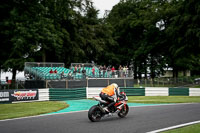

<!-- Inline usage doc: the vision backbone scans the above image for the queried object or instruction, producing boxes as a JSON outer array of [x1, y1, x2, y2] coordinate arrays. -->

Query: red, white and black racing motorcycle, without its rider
[[88, 92, 129, 122]]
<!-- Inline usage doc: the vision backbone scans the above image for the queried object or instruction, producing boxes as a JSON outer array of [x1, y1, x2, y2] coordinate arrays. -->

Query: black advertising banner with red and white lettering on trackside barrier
[[0, 89, 38, 103]]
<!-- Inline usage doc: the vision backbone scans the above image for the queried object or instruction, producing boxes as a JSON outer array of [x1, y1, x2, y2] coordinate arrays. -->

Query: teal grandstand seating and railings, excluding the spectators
[[24, 62, 121, 80]]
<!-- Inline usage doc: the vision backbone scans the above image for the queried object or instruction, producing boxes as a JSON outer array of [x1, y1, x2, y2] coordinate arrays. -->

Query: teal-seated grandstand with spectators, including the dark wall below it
[[24, 62, 133, 88]]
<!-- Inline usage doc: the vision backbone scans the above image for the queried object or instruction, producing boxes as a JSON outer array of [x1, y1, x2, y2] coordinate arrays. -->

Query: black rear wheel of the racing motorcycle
[[88, 105, 102, 122]]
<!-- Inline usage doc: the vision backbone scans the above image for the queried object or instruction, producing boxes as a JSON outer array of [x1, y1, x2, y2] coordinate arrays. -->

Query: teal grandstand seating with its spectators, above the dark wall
[[24, 62, 133, 80]]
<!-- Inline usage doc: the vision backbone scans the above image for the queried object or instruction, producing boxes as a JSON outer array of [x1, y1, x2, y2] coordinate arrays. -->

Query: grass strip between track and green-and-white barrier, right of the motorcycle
[[128, 96, 200, 103]]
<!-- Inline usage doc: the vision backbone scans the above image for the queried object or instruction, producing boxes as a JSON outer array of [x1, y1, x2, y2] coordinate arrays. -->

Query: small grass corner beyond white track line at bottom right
[[162, 124, 200, 133]]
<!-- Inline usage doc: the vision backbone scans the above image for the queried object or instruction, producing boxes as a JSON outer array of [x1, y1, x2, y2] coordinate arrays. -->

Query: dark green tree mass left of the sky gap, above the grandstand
[[0, 0, 114, 79]]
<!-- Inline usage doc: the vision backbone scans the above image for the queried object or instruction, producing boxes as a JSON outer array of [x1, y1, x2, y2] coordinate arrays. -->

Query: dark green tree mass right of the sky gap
[[107, 0, 200, 78]]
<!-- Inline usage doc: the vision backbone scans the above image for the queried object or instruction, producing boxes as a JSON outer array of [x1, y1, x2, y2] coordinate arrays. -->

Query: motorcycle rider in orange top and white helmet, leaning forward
[[99, 83, 120, 113]]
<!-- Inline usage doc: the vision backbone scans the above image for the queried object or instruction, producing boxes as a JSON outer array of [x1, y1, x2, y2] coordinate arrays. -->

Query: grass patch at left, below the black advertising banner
[[0, 101, 69, 120]]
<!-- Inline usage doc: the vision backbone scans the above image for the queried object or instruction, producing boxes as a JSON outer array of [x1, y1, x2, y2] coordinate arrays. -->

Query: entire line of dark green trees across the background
[[0, 0, 200, 79]]
